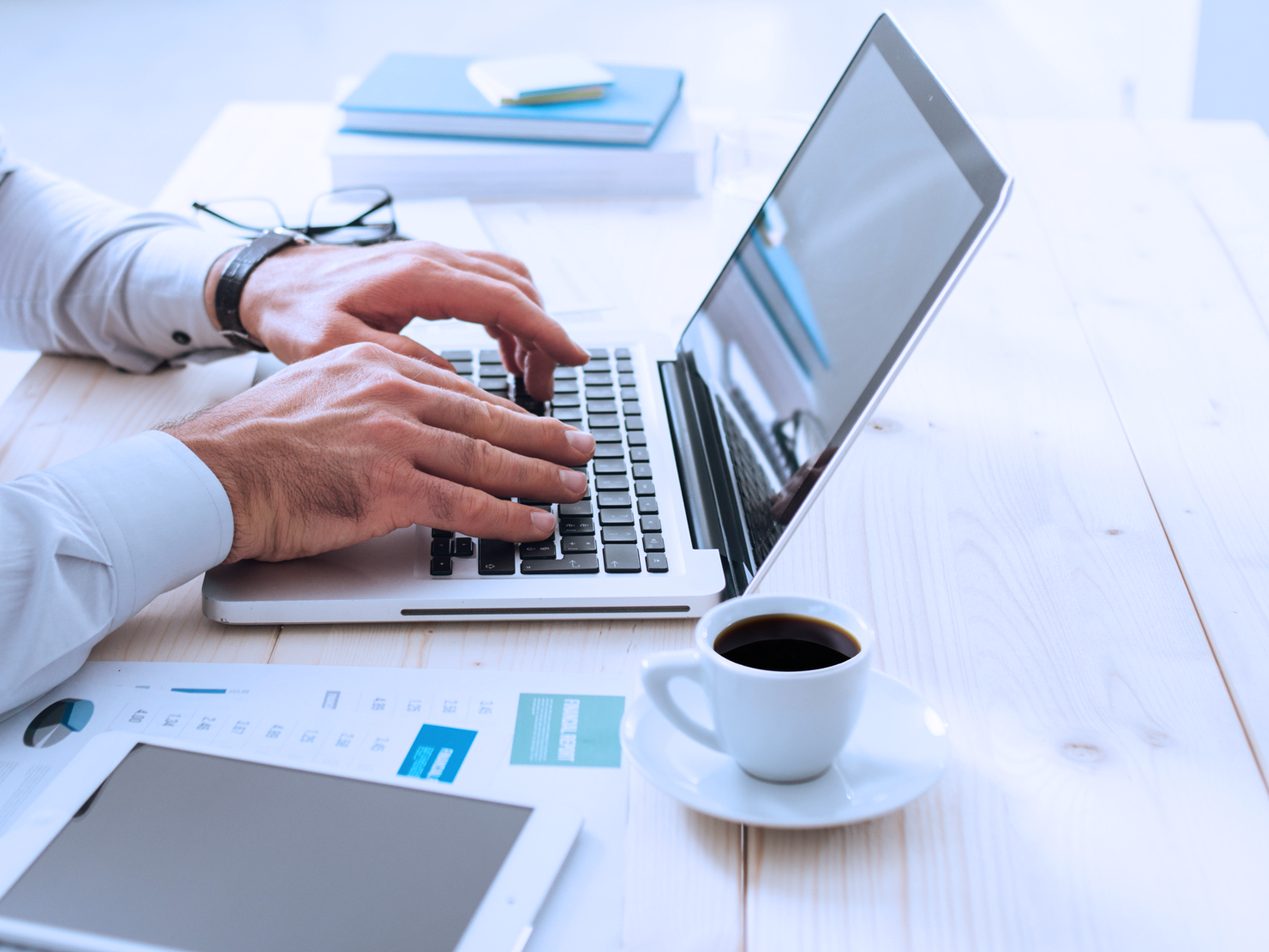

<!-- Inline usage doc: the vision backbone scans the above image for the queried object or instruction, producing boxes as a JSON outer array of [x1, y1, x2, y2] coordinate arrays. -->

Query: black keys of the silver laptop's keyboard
[[430, 348, 670, 578]]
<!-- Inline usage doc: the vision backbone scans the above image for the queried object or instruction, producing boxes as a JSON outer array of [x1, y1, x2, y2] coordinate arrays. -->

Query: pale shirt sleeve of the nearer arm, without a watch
[[0, 432, 233, 716]]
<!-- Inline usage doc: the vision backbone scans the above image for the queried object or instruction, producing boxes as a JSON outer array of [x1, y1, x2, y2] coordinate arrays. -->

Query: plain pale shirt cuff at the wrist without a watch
[[47, 431, 233, 630]]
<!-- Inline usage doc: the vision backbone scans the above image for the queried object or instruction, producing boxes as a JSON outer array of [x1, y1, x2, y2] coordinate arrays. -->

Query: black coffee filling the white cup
[[714, 614, 862, 671]]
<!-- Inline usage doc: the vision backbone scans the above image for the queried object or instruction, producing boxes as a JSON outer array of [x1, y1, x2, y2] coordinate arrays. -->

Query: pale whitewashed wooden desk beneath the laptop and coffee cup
[[0, 104, 1269, 949]]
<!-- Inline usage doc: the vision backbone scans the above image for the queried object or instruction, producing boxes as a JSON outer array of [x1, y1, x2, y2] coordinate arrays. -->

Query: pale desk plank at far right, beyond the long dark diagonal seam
[[1015, 123, 1269, 770]]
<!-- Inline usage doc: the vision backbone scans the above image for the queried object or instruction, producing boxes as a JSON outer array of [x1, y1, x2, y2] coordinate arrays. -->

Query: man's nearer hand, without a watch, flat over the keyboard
[[166, 344, 595, 562]]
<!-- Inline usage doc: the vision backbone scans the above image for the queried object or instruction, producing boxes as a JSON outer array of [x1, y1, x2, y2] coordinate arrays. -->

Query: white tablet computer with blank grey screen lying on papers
[[0, 734, 581, 952]]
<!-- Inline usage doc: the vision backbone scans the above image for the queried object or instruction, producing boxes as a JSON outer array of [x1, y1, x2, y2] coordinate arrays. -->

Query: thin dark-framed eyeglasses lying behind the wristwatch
[[193, 187, 401, 245]]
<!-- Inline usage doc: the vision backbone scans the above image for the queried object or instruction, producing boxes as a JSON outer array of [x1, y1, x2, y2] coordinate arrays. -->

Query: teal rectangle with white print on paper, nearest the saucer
[[511, 694, 626, 767]]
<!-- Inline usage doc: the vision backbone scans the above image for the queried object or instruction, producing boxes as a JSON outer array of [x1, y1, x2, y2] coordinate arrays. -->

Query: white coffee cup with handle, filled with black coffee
[[642, 595, 874, 783]]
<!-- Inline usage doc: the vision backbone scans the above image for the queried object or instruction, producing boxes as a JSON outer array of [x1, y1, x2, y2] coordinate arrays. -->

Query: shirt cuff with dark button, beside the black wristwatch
[[127, 225, 242, 360]]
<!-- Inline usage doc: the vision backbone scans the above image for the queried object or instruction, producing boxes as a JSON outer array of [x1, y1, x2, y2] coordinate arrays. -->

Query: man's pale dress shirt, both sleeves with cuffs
[[0, 135, 233, 716]]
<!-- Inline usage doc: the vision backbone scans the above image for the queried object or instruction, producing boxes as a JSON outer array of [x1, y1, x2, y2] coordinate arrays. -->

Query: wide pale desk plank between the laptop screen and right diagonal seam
[[746, 123, 1269, 949]]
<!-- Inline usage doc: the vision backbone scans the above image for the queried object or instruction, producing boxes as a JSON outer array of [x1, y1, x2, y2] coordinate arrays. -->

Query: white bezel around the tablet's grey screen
[[0, 731, 581, 952]]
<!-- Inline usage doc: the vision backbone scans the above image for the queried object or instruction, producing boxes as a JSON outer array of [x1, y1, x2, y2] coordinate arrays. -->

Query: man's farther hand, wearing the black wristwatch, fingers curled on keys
[[208, 241, 586, 400]]
